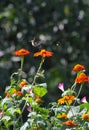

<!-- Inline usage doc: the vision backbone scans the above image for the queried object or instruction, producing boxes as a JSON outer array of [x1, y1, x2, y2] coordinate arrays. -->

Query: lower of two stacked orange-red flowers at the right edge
[[75, 72, 89, 83]]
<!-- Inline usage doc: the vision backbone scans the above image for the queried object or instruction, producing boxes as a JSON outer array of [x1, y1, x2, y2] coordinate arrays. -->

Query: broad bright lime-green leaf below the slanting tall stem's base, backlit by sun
[[33, 86, 47, 97]]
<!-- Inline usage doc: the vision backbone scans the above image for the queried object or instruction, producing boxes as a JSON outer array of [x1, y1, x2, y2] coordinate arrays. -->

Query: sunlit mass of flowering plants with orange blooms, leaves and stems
[[0, 49, 89, 130]]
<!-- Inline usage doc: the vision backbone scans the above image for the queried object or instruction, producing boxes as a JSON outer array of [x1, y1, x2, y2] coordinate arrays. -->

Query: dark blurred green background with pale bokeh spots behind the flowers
[[0, 0, 89, 101]]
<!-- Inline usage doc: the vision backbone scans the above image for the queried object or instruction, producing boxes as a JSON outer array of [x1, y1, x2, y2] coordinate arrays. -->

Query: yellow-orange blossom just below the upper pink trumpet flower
[[58, 95, 75, 104]]
